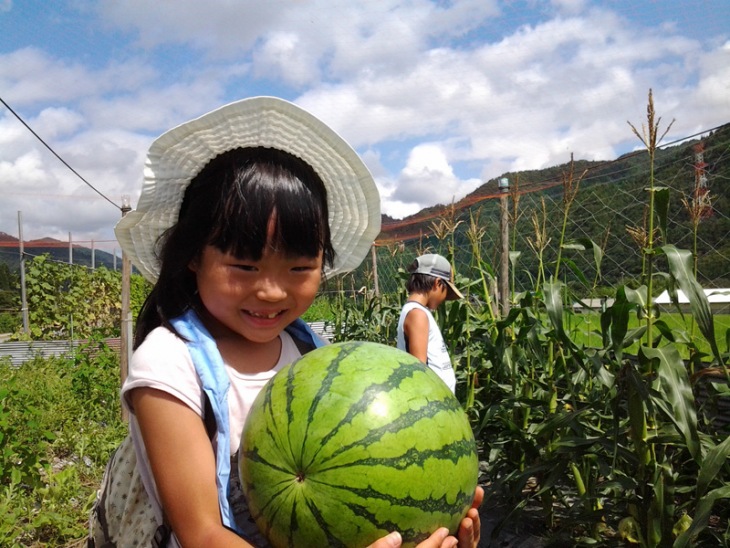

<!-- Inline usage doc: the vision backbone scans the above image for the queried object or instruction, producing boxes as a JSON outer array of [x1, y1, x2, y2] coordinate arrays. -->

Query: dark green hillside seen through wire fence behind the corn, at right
[[339, 126, 730, 297]]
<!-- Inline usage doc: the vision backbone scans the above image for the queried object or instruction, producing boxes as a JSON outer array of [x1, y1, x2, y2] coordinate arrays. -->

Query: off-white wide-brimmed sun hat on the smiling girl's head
[[114, 97, 380, 282]]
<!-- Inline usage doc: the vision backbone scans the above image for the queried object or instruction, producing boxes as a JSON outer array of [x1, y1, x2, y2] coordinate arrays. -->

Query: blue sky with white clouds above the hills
[[0, 0, 730, 251]]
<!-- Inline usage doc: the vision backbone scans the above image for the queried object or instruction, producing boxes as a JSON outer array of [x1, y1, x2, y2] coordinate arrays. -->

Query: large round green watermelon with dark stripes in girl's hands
[[239, 342, 478, 548]]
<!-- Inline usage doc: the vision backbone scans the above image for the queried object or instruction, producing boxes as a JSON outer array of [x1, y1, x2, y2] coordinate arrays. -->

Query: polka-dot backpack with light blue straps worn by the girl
[[87, 310, 325, 548]]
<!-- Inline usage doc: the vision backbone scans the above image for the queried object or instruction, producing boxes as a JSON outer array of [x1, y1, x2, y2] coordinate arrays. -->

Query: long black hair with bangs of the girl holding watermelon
[[134, 147, 335, 348]]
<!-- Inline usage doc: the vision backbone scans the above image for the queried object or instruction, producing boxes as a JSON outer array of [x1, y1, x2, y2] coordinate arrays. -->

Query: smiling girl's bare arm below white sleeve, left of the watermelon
[[129, 388, 250, 547]]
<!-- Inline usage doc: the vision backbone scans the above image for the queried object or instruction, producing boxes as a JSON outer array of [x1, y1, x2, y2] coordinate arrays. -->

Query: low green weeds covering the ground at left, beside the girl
[[0, 341, 126, 546]]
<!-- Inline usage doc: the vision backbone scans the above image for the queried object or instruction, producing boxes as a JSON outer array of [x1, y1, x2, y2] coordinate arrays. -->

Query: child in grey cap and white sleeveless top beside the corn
[[397, 254, 464, 392]]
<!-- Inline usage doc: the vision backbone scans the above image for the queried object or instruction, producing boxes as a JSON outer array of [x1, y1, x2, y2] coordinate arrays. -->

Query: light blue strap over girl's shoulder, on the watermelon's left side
[[170, 310, 236, 529]]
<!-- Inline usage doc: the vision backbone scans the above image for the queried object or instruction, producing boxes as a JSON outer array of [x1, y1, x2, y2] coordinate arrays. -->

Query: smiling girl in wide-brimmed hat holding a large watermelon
[[116, 97, 482, 548]]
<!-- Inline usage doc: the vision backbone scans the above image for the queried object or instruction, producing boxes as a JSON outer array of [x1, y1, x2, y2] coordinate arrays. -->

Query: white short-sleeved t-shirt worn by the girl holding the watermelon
[[122, 327, 301, 547]]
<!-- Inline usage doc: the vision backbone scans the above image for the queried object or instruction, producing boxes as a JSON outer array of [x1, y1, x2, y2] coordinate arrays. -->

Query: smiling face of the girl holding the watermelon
[[190, 246, 322, 343]]
